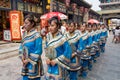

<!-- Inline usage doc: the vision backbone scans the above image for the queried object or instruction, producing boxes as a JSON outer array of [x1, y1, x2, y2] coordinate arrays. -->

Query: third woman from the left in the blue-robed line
[[65, 22, 81, 80]]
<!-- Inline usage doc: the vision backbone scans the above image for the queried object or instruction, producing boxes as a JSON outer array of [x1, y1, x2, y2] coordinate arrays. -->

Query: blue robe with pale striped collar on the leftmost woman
[[19, 29, 43, 79]]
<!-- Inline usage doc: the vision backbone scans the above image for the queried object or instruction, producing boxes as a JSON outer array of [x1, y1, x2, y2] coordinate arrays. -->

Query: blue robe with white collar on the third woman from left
[[65, 32, 81, 80]]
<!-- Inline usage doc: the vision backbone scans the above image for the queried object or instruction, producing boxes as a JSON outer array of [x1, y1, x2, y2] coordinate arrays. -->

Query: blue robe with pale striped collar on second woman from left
[[46, 33, 72, 80]]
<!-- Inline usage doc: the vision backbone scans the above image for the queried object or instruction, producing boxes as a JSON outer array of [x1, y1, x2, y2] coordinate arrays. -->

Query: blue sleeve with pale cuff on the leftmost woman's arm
[[30, 33, 42, 61]]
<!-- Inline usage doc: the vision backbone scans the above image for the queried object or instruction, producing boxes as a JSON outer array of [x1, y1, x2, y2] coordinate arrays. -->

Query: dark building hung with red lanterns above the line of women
[[46, 0, 91, 23]]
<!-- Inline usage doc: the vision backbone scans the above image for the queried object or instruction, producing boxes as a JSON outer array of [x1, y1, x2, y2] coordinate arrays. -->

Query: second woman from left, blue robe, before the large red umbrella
[[45, 17, 72, 80]]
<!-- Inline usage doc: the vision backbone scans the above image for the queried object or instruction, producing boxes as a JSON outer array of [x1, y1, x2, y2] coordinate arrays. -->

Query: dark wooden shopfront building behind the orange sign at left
[[0, 0, 45, 40]]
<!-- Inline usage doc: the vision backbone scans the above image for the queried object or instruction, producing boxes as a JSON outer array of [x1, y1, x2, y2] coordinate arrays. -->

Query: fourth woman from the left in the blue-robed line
[[79, 24, 90, 77]]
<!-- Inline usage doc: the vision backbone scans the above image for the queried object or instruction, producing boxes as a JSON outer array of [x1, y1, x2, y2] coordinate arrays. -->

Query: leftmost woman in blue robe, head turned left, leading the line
[[19, 14, 43, 80]]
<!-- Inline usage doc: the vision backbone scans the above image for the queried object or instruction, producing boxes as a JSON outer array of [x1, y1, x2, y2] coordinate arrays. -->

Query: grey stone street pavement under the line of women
[[0, 35, 120, 80]]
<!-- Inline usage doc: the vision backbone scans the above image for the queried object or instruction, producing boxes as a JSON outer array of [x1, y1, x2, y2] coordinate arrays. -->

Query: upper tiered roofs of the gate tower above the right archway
[[99, 0, 120, 25]]
